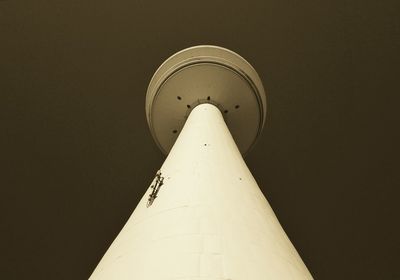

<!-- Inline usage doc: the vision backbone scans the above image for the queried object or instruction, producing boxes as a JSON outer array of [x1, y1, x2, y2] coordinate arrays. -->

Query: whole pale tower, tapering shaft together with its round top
[[90, 46, 312, 280]]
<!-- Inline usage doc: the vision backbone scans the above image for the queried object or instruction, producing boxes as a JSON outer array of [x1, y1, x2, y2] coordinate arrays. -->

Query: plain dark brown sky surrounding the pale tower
[[0, 0, 400, 279]]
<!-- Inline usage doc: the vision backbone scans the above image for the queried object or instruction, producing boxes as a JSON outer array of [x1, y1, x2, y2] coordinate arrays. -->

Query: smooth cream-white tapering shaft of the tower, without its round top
[[90, 104, 312, 280]]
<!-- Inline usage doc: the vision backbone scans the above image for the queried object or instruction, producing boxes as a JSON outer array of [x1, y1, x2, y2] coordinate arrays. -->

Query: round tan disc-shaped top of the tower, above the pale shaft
[[146, 45, 267, 154]]
